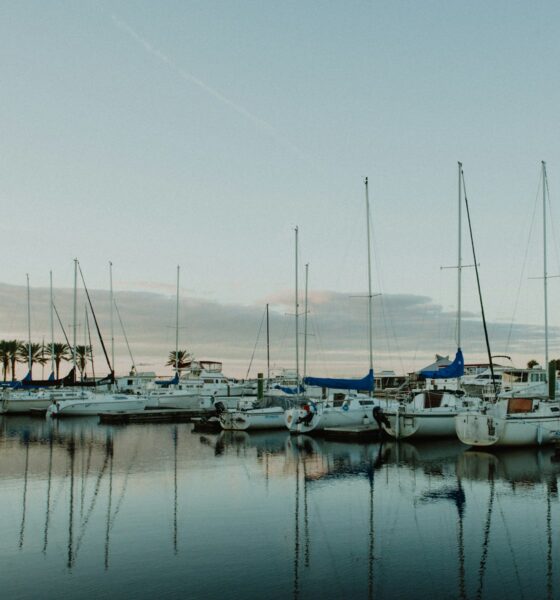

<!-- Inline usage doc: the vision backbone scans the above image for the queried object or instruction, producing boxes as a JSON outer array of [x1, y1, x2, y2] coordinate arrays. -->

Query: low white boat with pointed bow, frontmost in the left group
[[47, 391, 146, 417]]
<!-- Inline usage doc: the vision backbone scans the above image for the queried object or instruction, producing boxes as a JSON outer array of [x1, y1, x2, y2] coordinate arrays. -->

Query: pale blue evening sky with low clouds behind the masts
[[0, 0, 560, 375]]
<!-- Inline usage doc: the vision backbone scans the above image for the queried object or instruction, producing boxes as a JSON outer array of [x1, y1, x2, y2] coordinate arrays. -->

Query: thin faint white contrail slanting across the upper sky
[[111, 14, 306, 159]]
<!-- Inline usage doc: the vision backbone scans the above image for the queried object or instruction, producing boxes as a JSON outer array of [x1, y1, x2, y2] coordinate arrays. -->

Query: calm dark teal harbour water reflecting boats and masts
[[0, 417, 560, 600]]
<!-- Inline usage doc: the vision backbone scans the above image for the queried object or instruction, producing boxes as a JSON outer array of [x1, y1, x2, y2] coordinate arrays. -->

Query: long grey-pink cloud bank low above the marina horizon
[[0, 284, 560, 376]]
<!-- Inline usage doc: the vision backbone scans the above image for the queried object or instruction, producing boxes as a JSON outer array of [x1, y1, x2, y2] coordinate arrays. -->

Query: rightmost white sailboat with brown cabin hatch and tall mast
[[455, 161, 560, 446]]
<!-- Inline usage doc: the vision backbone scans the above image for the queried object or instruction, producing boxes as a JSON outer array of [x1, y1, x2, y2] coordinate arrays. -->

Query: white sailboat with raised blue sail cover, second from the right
[[381, 163, 481, 439]]
